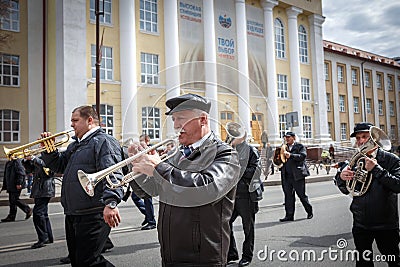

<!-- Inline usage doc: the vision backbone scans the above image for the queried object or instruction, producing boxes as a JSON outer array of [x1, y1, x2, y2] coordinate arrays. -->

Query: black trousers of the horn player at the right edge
[[352, 227, 400, 267]]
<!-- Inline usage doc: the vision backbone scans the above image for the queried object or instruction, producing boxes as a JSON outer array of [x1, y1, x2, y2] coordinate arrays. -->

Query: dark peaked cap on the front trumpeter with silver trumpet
[[165, 94, 211, 115]]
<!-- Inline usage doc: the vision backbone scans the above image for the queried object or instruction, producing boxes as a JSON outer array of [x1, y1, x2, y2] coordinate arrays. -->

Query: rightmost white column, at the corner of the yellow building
[[308, 14, 330, 143]]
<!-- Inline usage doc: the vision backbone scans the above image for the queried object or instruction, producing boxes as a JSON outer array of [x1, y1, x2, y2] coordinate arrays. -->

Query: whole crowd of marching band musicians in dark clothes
[[1, 94, 400, 266]]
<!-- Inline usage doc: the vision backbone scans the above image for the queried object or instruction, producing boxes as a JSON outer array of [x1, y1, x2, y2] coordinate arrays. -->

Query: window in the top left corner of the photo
[[0, 0, 20, 32]]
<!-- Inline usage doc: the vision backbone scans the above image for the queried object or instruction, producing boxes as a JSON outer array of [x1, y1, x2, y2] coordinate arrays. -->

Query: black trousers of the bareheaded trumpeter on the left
[[65, 212, 114, 267]]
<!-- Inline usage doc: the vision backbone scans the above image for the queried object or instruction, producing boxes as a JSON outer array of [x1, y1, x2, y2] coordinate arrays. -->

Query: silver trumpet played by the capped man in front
[[78, 138, 179, 197]]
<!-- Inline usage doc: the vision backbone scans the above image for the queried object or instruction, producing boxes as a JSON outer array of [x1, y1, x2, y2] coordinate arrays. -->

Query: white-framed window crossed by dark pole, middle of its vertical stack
[[91, 45, 113, 81]]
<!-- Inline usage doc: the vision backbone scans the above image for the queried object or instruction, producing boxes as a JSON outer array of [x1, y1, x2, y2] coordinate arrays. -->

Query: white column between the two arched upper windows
[[286, 7, 303, 140]]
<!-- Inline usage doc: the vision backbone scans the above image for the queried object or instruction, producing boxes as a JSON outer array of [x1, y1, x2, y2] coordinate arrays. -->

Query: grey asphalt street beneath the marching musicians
[[0, 181, 386, 267]]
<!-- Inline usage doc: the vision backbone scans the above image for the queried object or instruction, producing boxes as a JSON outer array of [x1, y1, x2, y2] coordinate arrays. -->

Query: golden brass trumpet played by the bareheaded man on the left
[[4, 130, 74, 160]]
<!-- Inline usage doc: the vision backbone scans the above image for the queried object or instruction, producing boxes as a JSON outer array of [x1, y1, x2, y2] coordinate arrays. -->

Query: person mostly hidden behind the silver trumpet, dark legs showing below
[[131, 134, 157, 230]]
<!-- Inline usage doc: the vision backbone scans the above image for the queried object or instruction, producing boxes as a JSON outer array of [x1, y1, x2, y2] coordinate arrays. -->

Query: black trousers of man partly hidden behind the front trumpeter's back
[[228, 198, 258, 261]]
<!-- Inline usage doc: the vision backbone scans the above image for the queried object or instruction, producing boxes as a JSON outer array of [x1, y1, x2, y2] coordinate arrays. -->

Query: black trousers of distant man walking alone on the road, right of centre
[[282, 175, 312, 217]]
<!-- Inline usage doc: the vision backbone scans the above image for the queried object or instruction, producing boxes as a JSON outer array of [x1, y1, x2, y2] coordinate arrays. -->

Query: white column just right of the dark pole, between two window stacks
[[119, 1, 140, 142]]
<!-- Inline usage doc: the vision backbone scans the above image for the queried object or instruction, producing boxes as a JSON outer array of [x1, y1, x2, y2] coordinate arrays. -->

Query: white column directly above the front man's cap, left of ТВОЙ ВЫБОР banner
[[203, 0, 221, 137]]
